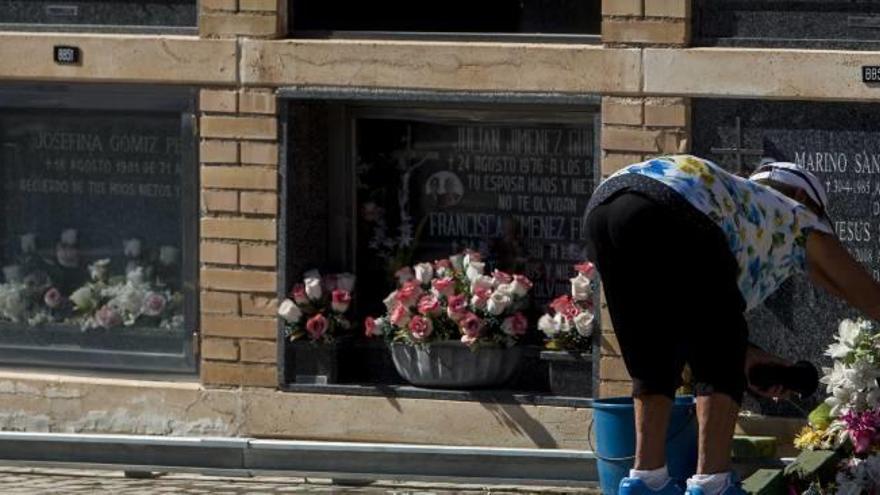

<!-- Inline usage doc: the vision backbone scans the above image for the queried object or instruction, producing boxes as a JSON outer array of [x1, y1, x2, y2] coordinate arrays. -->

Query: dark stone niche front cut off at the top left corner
[[0, 0, 198, 33]]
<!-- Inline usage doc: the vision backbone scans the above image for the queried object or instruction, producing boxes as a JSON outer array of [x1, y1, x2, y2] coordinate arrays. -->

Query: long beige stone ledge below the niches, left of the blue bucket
[[0, 372, 592, 450]]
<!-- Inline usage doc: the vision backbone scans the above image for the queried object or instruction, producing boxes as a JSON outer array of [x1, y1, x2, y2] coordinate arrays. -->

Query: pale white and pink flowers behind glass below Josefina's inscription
[[0, 229, 184, 331]]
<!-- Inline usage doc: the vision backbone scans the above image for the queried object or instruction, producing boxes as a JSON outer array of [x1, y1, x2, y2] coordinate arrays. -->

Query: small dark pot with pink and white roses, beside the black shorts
[[538, 262, 596, 397]]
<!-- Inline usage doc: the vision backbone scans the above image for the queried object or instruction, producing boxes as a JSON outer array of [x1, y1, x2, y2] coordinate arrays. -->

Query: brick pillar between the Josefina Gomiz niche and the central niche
[[199, 90, 278, 387]]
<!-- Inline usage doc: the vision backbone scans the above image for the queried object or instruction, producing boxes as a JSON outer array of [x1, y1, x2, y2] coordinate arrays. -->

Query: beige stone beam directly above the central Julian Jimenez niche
[[241, 40, 641, 94]]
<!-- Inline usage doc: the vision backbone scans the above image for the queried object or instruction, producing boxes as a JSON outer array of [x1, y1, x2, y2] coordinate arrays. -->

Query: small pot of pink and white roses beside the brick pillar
[[278, 270, 355, 384]]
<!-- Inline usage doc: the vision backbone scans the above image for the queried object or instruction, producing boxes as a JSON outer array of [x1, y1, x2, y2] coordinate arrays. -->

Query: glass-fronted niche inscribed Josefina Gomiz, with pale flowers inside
[[0, 87, 197, 372]]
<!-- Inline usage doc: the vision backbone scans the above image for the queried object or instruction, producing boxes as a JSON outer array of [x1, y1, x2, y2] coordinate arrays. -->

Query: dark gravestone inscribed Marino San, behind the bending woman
[[693, 99, 880, 415]]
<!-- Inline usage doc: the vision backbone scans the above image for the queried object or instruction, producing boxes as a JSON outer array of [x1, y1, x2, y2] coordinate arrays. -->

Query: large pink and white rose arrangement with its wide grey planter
[[365, 251, 532, 387]]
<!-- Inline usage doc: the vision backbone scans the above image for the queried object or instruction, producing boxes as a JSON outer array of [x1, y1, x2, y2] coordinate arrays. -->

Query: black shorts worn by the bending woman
[[586, 190, 748, 403]]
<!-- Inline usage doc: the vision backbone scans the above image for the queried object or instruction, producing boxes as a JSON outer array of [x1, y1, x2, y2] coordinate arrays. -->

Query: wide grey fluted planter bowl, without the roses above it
[[391, 341, 522, 389]]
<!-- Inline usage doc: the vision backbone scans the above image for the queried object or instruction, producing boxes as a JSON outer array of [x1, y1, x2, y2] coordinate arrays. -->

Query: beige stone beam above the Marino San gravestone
[[644, 48, 880, 100]]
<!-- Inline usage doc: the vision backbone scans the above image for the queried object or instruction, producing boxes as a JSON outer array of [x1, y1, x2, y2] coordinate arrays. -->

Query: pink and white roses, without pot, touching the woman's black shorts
[[538, 262, 596, 351]]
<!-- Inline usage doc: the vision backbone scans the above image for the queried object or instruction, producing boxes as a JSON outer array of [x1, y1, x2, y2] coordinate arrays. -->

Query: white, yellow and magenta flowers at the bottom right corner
[[791, 319, 880, 494]]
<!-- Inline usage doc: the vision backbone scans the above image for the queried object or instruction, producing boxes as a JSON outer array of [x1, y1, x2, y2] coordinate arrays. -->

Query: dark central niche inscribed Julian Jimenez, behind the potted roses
[[280, 90, 598, 393]]
